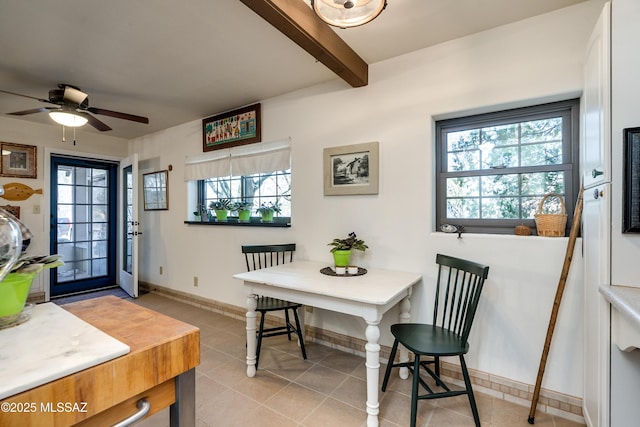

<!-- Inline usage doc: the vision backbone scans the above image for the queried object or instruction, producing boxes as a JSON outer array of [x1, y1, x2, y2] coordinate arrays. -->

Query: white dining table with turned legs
[[233, 261, 422, 427]]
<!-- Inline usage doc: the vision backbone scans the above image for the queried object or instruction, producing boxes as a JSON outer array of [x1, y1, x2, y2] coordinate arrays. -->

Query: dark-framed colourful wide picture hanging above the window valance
[[202, 104, 261, 151]]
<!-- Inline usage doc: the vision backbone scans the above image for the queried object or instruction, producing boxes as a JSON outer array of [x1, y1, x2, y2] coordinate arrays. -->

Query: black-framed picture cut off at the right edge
[[622, 127, 640, 233]]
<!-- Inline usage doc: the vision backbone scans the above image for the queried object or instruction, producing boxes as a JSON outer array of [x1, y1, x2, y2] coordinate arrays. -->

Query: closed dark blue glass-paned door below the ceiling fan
[[50, 156, 118, 296]]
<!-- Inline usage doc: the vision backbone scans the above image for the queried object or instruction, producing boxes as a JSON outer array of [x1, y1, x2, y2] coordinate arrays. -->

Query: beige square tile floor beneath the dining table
[[126, 293, 580, 427]]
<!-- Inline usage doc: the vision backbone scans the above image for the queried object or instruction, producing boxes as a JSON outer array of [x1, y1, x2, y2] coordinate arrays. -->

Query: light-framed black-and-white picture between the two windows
[[324, 142, 378, 196]]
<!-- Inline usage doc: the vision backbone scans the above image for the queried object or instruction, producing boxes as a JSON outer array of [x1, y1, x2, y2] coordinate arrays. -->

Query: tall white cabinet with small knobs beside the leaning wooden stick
[[581, 3, 612, 427]]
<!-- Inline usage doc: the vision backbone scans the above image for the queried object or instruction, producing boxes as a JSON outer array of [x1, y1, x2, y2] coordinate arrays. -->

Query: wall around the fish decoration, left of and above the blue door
[[0, 116, 128, 298]]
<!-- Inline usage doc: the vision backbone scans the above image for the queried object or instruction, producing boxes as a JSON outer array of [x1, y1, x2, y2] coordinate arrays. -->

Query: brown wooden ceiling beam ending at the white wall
[[240, 0, 369, 87]]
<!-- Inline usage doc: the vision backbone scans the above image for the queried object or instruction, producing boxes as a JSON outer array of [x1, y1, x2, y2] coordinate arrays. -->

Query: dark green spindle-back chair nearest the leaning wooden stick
[[382, 254, 489, 427]]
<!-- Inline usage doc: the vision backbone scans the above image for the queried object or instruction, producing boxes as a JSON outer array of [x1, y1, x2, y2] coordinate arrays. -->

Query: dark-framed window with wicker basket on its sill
[[436, 99, 579, 234]]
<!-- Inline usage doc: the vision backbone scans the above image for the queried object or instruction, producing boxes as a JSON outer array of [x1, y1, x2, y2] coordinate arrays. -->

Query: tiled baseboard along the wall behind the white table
[[138, 282, 584, 423]]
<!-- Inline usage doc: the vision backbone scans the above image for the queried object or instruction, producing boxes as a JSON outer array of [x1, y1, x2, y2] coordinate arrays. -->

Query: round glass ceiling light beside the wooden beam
[[311, 0, 387, 28]]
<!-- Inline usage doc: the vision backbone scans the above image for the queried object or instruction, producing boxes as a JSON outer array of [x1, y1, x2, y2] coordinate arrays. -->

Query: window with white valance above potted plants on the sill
[[198, 169, 291, 221]]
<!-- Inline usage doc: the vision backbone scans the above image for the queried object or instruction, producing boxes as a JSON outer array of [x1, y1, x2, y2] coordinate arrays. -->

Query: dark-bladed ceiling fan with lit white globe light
[[0, 83, 149, 132]]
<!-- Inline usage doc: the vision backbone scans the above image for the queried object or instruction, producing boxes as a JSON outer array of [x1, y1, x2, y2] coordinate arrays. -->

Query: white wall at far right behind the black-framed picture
[[611, 0, 640, 427]]
